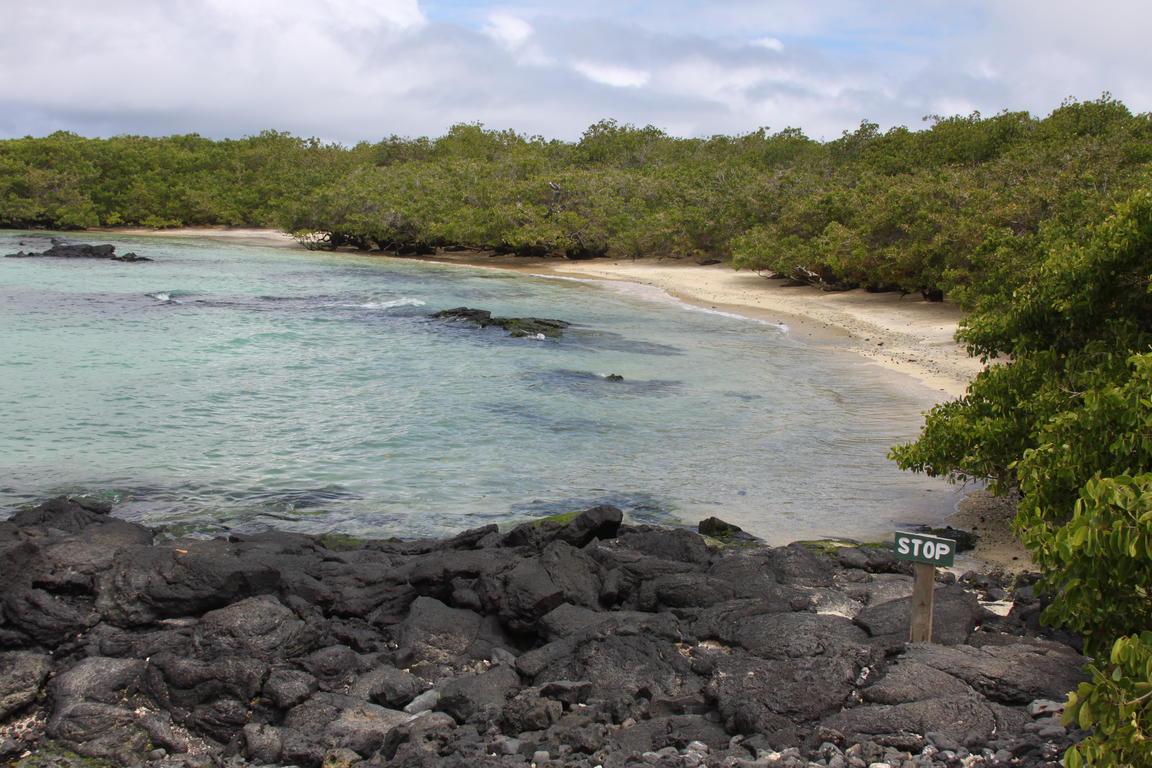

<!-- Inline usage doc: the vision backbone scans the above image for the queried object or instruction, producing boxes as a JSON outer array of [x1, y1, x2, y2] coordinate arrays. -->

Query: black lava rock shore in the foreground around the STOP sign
[[0, 497, 1084, 768]]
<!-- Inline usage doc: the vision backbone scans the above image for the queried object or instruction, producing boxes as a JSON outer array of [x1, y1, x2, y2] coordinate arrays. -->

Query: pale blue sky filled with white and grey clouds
[[0, 0, 1152, 145]]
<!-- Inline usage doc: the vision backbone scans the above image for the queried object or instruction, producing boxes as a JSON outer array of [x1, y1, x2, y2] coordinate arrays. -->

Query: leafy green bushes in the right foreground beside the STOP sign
[[893, 191, 1152, 766]]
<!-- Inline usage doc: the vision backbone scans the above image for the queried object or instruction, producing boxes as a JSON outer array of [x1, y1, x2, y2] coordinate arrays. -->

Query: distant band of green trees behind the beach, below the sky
[[0, 94, 1152, 305]]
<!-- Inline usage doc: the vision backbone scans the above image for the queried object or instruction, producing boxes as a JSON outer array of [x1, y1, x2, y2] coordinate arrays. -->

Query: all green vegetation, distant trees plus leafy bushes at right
[[0, 94, 1152, 768]]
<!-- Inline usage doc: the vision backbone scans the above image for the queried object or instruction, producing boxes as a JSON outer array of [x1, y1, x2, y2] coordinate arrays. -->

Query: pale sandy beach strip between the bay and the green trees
[[88, 227, 1031, 573]]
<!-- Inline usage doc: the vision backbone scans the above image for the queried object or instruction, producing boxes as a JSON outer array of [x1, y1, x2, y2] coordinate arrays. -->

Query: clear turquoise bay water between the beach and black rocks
[[0, 233, 956, 542]]
